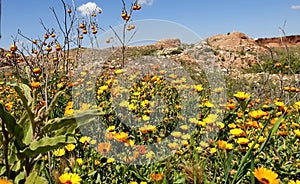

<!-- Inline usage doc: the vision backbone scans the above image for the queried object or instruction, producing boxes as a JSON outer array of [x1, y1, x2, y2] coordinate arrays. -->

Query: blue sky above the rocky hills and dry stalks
[[0, 0, 300, 49]]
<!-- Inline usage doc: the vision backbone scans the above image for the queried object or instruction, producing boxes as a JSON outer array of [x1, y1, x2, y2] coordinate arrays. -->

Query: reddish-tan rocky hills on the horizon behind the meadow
[[0, 32, 300, 70]]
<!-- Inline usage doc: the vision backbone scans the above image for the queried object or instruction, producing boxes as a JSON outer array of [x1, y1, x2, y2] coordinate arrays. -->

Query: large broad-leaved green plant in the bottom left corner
[[0, 84, 99, 183]]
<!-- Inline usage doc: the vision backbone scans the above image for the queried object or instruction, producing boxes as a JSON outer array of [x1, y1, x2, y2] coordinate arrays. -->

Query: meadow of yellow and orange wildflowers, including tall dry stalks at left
[[0, 0, 300, 184]]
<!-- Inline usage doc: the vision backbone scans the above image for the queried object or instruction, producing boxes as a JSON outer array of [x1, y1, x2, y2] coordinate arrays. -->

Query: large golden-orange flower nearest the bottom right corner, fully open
[[253, 167, 280, 184]]
